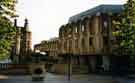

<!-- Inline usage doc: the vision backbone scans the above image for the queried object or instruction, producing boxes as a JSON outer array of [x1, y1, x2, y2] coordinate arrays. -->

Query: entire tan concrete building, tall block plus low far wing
[[35, 5, 127, 72]]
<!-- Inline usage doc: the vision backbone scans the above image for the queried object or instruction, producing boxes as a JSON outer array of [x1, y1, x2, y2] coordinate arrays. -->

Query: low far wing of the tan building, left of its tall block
[[34, 38, 58, 57]]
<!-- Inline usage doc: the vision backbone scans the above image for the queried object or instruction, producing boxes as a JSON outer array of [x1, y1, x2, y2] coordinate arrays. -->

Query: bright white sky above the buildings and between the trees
[[16, 0, 127, 45]]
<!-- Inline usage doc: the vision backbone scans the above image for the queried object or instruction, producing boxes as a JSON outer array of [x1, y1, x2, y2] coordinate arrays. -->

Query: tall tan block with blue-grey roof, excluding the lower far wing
[[58, 5, 123, 72]]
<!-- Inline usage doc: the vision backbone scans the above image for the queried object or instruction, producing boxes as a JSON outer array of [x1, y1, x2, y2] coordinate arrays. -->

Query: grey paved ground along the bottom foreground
[[0, 73, 135, 83]]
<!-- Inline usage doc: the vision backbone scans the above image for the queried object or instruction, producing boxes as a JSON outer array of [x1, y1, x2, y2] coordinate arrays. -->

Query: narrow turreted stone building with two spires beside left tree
[[12, 19, 32, 63]]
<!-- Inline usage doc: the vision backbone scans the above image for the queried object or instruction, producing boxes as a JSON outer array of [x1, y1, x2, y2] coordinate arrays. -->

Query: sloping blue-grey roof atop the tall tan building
[[69, 5, 124, 23]]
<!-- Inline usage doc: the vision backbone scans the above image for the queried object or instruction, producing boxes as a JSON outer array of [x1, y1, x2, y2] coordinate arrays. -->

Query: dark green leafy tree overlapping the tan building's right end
[[113, 0, 135, 55]]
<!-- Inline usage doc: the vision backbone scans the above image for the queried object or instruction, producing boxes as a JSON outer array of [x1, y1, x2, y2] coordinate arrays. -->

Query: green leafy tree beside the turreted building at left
[[0, 0, 17, 60]]
